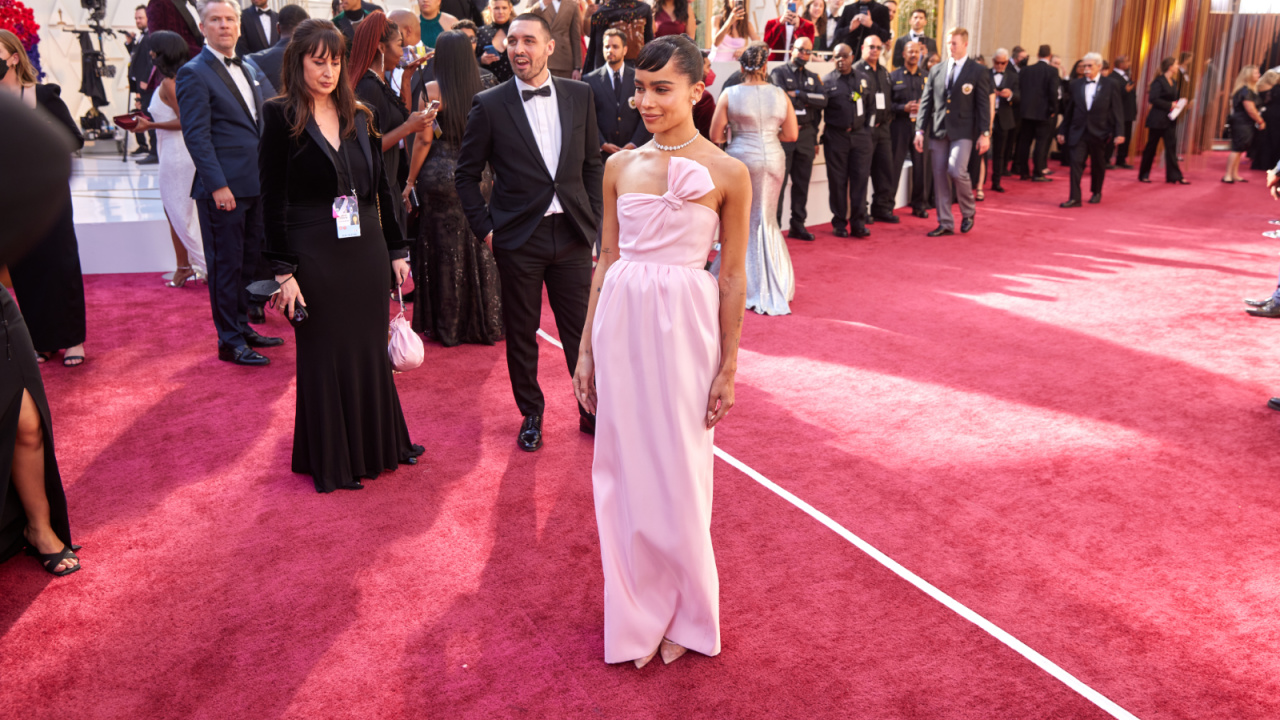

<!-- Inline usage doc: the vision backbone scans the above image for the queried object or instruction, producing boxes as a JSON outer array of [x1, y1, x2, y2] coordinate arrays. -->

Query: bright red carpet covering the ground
[[0, 156, 1280, 719]]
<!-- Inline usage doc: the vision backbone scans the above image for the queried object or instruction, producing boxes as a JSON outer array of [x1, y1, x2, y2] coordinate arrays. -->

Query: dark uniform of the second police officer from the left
[[822, 69, 874, 237]]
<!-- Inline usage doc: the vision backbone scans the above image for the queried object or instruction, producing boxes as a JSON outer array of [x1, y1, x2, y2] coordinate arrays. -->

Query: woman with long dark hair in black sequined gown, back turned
[[404, 31, 503, 347]]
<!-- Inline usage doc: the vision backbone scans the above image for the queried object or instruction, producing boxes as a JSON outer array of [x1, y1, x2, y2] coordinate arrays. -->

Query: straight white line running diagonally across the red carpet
[[538, 328, 1138, 720]]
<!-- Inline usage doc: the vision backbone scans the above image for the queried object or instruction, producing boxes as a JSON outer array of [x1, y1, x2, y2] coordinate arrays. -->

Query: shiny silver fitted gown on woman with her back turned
[[712, 85, 796, 315]]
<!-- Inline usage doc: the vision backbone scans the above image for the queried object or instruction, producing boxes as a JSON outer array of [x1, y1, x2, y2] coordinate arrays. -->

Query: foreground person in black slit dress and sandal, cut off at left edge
[[0, 63, 79, 575]]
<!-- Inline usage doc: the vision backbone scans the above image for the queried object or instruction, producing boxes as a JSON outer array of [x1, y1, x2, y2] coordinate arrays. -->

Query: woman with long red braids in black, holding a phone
[[348, 10, 428, 239]]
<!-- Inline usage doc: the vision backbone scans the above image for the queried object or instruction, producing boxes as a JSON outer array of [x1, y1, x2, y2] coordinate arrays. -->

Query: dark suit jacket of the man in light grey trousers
[[915, 58, 992, 142]]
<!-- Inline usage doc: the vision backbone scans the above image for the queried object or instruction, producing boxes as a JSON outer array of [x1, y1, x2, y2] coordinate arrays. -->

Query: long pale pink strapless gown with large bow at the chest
[[591, 158, 721, 662]]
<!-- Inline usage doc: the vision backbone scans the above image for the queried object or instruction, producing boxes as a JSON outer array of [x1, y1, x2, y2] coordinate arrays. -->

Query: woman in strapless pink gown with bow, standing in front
[[573, 36, 751, 667]]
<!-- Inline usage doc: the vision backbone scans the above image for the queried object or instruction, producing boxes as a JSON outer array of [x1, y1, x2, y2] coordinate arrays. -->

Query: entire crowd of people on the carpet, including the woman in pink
[[0, 0, 1280, 666]]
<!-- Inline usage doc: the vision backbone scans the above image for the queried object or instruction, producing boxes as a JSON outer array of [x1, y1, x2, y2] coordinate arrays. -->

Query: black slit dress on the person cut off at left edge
[[0, 88, 83, 562]]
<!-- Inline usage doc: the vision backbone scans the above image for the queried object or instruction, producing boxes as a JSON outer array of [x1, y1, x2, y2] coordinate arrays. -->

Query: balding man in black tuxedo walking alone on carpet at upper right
[[1057, 53, 1125, 208]]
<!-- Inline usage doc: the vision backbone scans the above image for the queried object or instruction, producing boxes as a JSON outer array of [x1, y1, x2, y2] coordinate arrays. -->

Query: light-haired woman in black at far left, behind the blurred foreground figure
[[0, 29, 84, 368]]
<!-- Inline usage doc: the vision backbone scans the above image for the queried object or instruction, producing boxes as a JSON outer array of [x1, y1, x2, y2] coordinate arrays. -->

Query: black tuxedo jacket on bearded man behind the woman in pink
[[456, 76, 604, 250]]
